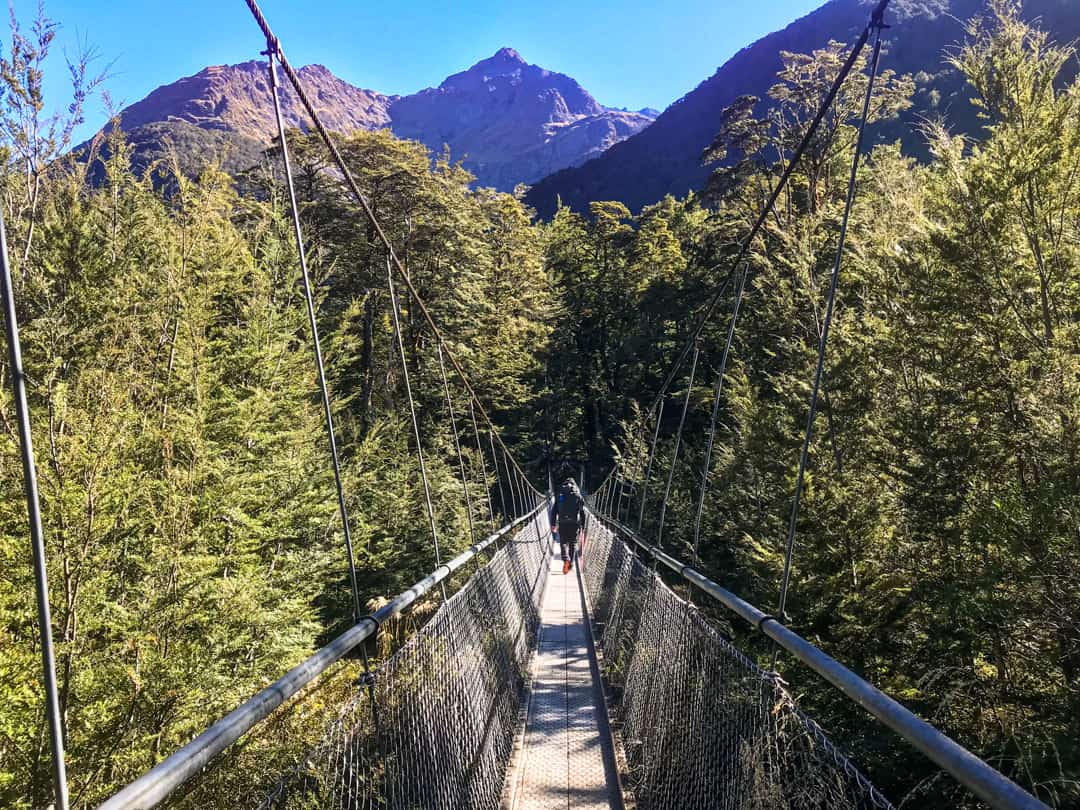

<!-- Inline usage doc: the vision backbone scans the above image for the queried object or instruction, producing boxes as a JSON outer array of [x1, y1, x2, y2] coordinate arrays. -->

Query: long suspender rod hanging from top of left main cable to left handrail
[[267, 49, 363, 621]]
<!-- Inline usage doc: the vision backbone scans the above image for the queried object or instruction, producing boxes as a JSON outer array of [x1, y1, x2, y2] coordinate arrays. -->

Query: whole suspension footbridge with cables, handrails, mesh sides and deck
[[0, 0, 1058, 810]]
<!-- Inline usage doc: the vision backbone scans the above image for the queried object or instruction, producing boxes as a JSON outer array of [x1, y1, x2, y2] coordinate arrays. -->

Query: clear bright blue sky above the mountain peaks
[[29, 0, 824, 142]]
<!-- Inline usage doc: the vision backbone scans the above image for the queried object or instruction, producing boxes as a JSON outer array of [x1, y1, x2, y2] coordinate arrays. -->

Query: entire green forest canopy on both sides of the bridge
[[0, 0, 1080, 808]]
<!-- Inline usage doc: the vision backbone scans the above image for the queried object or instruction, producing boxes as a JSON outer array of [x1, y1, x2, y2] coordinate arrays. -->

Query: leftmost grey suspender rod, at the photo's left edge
[[0, 213, 68, 810]]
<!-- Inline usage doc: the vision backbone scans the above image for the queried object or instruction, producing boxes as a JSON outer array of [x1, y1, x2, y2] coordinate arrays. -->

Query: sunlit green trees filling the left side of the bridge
[[0, 27, 550, 808]]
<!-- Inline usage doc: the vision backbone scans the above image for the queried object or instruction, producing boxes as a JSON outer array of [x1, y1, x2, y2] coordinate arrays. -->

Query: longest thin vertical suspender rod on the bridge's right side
[[772, 27, 883, 648]]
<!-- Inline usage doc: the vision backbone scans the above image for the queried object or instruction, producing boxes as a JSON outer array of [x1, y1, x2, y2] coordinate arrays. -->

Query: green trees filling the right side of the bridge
[[549, 0, 1080, 807]]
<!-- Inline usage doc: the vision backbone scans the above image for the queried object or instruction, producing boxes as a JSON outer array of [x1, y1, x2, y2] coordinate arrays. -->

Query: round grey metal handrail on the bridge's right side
[[589, 508, 1050, 810]]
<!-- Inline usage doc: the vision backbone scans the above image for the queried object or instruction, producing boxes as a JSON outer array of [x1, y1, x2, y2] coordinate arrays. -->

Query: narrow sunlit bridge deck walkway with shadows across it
[[504, 546, 622, 810]]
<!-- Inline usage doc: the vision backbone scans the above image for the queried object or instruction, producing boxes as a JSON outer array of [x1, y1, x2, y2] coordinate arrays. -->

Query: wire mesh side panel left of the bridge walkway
[[260, 510, 551, 810]]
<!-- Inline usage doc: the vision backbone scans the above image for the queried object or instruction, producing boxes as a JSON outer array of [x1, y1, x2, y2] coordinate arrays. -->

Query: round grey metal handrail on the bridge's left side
[[98, 502, 546, 810]]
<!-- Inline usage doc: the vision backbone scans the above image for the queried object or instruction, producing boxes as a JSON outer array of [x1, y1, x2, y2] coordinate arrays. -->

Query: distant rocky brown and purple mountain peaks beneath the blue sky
[[95, 48, 654, 191]]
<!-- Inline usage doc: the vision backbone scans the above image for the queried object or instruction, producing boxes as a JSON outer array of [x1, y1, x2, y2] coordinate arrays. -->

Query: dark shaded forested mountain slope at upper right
[[526, 0, 1080, 216]]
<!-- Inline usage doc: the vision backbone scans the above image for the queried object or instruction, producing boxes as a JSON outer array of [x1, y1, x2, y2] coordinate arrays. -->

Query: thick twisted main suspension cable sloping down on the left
[[244, 0, 537, 494]]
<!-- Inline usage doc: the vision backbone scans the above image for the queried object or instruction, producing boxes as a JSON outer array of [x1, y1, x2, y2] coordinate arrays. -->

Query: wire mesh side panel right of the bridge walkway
[[582, 515, 892, 810]]
